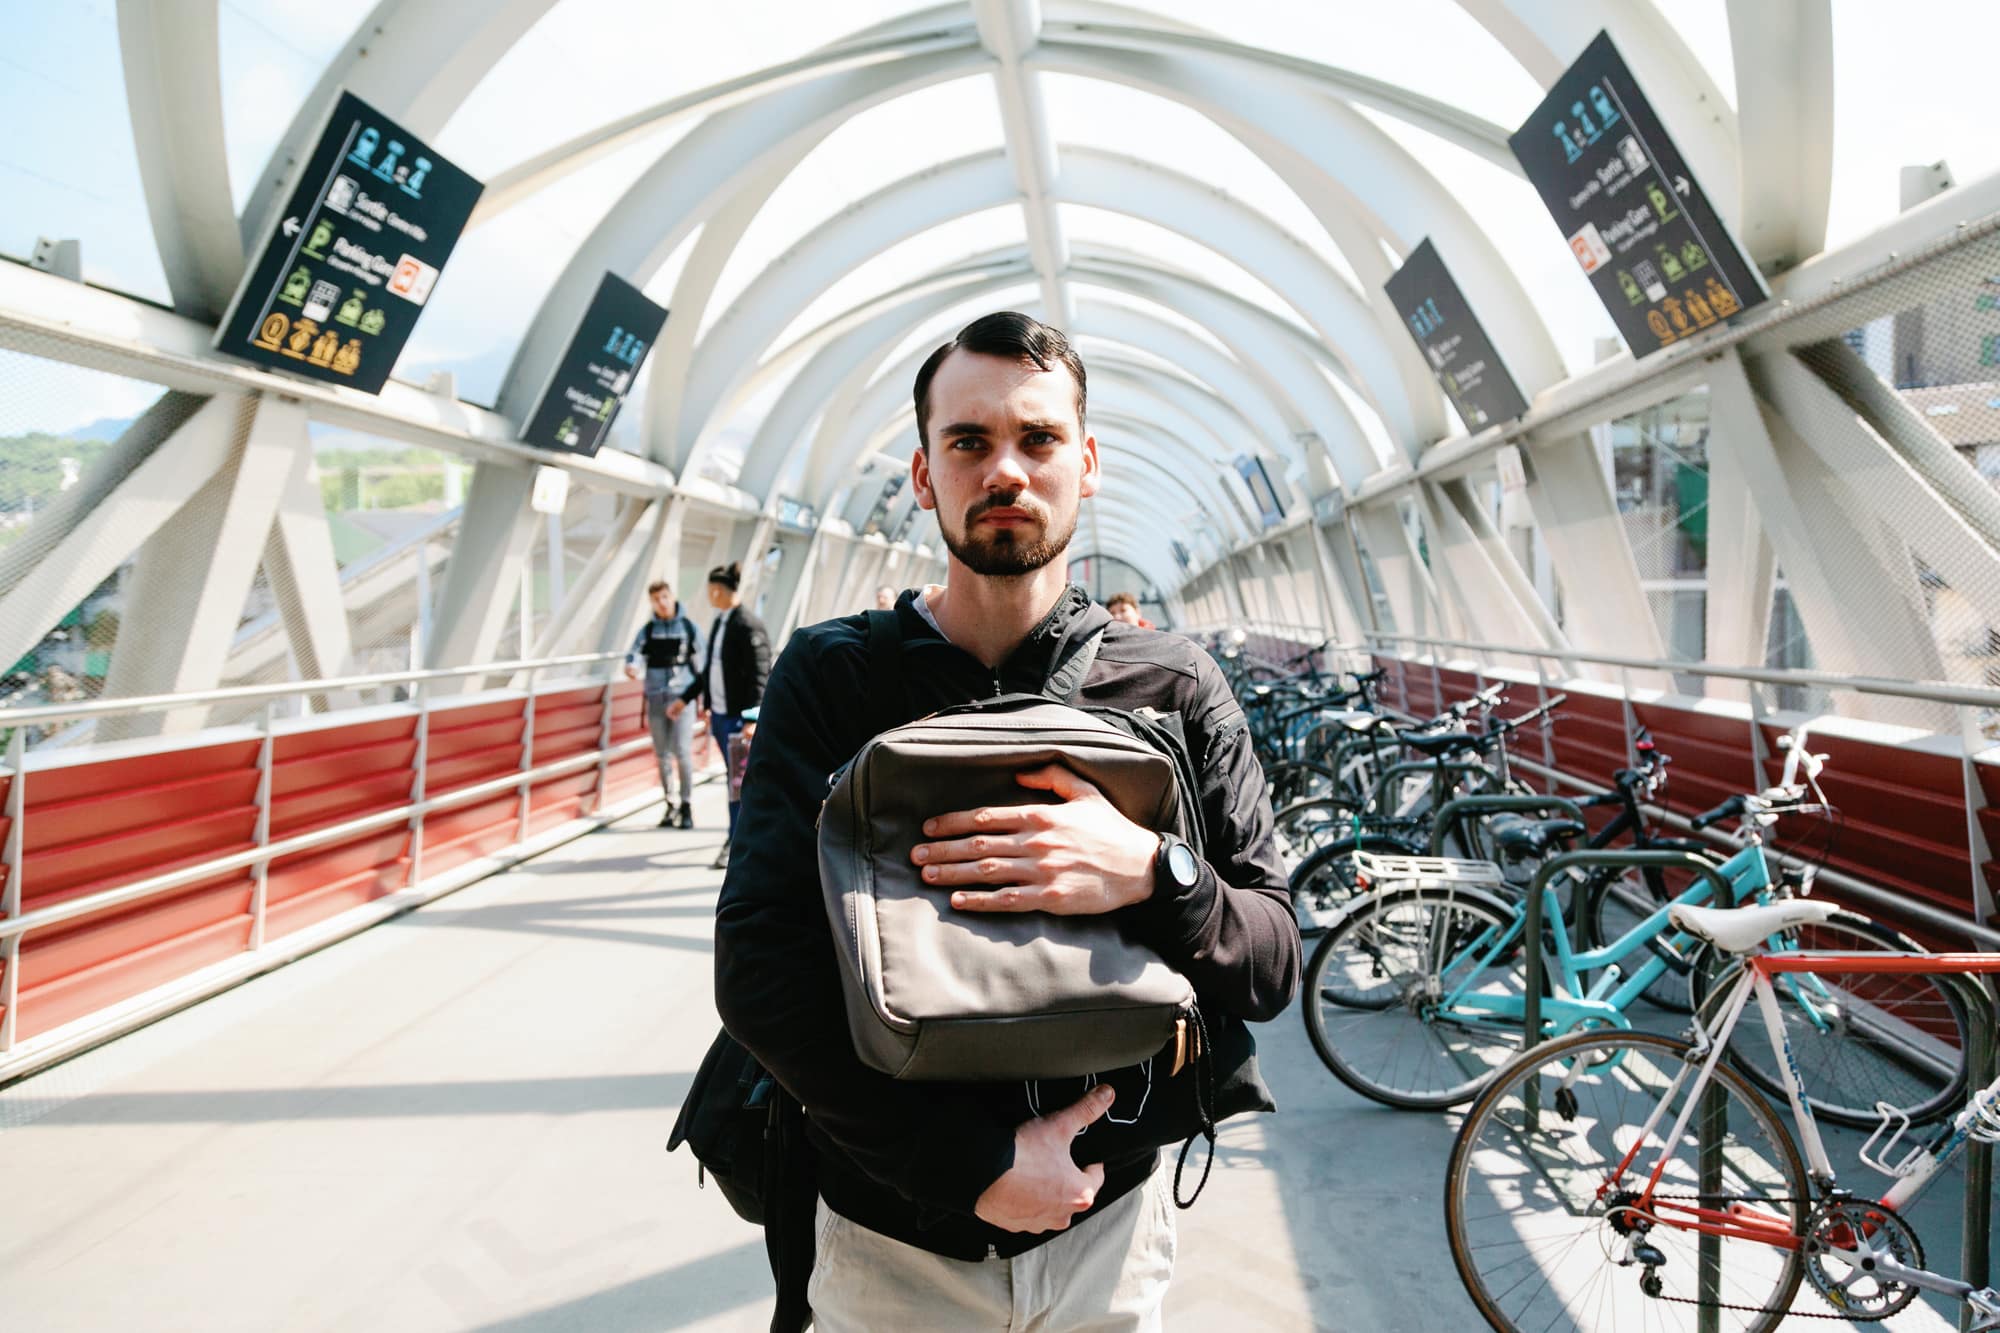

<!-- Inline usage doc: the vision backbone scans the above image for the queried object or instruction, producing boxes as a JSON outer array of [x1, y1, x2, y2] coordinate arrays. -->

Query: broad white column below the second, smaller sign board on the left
[[426, 462, 540, 693]]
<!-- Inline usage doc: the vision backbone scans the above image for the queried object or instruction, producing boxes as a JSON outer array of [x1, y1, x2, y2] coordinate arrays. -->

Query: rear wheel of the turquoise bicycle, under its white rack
[[1302, 889, 1524, 1111]]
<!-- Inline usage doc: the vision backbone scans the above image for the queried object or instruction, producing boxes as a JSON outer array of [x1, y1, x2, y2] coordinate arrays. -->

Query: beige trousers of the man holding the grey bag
[[808, 1171, 1174, 1333]]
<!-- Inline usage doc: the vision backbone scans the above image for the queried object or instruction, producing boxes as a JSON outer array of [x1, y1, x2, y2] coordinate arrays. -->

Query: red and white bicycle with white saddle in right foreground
[[1446, 901, 2000, 1333]]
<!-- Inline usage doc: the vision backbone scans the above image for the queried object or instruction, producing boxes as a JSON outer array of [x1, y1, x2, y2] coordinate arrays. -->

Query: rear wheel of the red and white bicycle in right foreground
[[1444, 1031, 1810, 1333]]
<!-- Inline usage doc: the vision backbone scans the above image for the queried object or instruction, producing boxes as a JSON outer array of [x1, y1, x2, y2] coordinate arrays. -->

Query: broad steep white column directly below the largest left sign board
[[98, 396, 308, 741]]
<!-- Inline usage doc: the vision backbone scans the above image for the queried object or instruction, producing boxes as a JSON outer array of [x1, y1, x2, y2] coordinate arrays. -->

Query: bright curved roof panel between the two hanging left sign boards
[[396, 122, 690, 404]]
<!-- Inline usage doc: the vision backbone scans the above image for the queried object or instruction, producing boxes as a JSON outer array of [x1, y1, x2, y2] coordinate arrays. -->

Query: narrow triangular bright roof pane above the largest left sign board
[[216, 0, 360, 212]]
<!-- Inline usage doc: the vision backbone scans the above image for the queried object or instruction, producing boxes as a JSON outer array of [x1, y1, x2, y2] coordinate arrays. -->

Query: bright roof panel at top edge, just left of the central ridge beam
[[438, 0, 944, 176]]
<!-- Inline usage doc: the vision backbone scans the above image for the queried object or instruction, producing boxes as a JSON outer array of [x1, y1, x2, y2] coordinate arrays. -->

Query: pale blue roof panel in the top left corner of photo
[[0, 0, 168, 302]]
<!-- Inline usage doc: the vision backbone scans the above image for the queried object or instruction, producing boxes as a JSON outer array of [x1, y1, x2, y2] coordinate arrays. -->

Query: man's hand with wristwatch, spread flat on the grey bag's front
[[910, 765, 1160, 917]]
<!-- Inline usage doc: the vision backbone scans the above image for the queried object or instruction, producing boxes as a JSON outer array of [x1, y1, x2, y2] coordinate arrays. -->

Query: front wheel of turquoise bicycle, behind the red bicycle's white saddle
[[1690, 911, 1968, 1129]]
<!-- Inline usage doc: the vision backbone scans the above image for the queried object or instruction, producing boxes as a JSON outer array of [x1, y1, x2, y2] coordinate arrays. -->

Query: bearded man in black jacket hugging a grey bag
[[716, 312, 1300, 1333]]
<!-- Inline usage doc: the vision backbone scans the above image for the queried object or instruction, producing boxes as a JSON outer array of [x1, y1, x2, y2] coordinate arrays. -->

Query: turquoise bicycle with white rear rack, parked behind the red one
[[1302, 729, 1966, 1123]]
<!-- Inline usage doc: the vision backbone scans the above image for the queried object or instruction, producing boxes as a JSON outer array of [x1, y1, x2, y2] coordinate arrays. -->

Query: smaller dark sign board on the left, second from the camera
[[520, 272, 666, 454]]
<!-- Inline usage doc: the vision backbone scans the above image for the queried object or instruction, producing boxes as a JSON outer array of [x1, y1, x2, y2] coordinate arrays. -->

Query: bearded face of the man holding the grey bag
[[910, 350, 1098, 578]]
